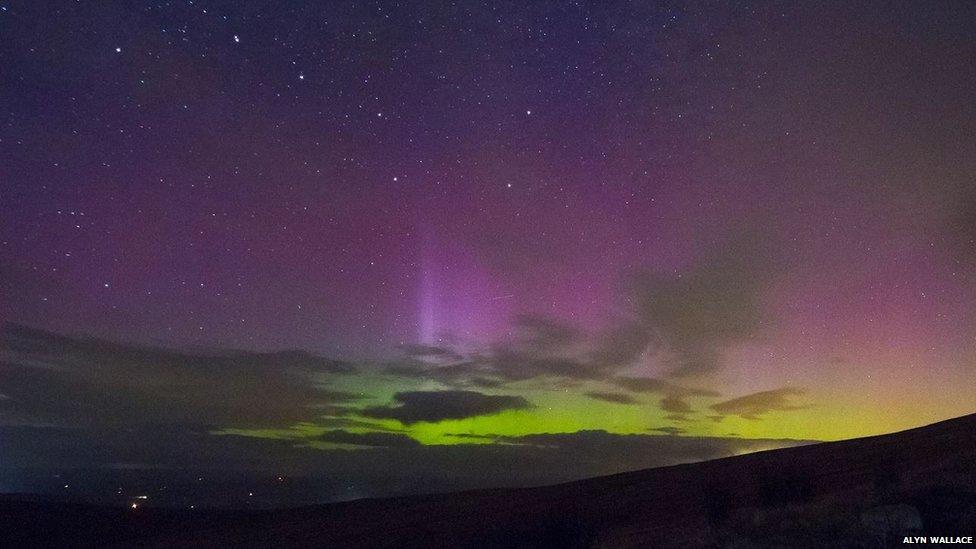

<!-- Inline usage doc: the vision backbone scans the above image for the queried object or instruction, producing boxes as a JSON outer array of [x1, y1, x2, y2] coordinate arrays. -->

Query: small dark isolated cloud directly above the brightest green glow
[[360, 391, 532, 425]]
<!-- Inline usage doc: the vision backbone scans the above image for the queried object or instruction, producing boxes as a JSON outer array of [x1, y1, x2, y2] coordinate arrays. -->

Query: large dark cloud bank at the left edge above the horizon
[[0, 324, 359, 427]]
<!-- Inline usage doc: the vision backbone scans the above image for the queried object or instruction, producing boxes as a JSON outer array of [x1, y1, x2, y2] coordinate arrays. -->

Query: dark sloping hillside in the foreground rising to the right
[[0, 415, 976, 547]]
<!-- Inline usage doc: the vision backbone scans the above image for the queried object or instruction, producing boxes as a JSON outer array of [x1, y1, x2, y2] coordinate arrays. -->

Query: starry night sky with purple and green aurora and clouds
[[0, 0, 976, 503]]
